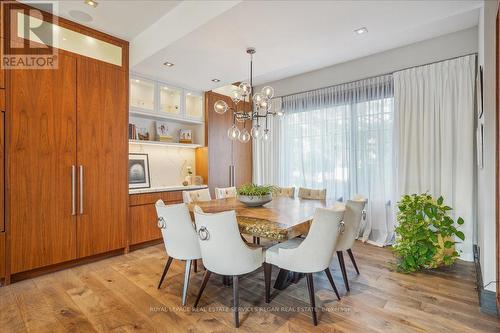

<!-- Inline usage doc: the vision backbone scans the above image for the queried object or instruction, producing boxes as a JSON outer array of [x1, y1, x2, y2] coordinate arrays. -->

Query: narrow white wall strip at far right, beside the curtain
[[478, 0, 497, 291]]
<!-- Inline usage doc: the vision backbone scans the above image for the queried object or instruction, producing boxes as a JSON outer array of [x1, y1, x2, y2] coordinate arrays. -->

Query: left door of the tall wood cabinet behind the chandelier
[[205, 92, 233, 196]]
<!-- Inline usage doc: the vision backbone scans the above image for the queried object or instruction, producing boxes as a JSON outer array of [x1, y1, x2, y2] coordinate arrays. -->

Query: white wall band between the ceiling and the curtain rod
[[256, 27, 478, 96]]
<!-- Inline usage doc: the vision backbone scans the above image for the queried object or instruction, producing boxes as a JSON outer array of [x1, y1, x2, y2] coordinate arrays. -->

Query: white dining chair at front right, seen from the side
[[264, 208, 344, 326]]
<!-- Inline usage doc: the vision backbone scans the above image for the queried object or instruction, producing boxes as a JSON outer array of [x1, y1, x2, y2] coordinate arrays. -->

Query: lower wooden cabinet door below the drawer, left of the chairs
[[129, 204, 161, 245]]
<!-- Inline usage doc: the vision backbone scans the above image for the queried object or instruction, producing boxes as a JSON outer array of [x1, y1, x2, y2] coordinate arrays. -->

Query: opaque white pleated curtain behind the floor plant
[[394, 55, 476, 260]]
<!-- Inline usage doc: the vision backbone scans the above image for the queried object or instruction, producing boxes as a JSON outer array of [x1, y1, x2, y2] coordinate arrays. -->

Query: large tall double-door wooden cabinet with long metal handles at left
[[6, 37, 128, 274]]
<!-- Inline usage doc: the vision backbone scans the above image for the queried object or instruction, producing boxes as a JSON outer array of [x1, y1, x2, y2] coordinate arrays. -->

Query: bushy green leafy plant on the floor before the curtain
[[393, 193, 465, 273]]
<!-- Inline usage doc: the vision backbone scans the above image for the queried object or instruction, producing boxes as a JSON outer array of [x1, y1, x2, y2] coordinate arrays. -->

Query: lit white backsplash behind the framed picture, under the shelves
[[129, 144, 196, 187]]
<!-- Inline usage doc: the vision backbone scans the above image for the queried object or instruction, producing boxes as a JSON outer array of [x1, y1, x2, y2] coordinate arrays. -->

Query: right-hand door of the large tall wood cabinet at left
[[77, 59, 128, 257]]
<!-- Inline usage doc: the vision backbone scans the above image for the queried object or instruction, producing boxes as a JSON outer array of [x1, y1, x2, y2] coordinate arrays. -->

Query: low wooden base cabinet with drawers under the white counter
[[129, 191, 182, 245]]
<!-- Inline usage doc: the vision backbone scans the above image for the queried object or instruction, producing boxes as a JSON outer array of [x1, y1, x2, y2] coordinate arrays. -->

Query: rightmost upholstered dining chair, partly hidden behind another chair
[[335, 196, 366, 291]]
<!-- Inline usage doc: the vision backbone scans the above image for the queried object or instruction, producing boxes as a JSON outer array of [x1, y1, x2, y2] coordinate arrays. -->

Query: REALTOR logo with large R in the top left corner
[[1, 1, 57, 69]]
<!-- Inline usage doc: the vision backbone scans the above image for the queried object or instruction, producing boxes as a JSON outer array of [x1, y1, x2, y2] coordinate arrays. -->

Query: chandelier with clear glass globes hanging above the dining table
[[214, 47, 283, 143]]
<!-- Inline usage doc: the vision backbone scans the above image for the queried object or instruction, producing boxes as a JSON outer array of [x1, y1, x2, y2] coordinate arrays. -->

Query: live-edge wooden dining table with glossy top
[[189, 197, 338, 289]]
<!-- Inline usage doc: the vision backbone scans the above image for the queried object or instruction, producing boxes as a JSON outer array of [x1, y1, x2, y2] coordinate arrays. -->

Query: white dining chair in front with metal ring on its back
[[190, 206, 264, 327]]
